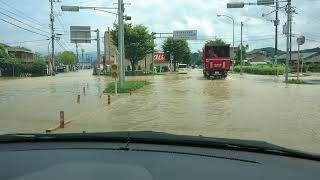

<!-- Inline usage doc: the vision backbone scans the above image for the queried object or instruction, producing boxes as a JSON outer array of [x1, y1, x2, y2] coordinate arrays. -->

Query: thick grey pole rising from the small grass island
[[118, 0, 125, 88]]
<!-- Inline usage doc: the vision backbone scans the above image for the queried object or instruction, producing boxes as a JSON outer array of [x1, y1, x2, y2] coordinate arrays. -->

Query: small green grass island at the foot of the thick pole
[[103, 81, 151, 93]]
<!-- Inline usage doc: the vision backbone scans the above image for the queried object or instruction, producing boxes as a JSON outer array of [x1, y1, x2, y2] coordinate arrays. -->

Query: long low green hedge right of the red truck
[[233, 65, 285, 75]]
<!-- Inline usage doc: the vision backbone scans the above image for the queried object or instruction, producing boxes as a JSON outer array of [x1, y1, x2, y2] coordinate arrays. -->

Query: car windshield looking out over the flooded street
[[0, 0, 320, 153]]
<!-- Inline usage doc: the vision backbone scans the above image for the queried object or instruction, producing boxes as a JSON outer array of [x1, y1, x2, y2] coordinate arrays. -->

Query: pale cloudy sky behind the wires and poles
[[0, 0, 320, 54]]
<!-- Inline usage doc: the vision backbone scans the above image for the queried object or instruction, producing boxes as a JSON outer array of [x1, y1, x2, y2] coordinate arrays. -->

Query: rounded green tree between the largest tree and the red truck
[[162, 37, 192, 71]]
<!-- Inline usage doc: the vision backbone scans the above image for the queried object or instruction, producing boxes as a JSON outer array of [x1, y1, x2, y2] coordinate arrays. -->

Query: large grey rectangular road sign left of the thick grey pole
[[70, 26, 91, 43]]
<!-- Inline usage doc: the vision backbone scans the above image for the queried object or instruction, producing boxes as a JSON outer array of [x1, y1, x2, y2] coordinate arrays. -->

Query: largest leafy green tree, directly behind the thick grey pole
[[111, 23, 154, 71]]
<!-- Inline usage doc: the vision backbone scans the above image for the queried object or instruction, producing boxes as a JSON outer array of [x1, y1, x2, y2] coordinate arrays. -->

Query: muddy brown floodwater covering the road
[[0, 70, 320, 153]]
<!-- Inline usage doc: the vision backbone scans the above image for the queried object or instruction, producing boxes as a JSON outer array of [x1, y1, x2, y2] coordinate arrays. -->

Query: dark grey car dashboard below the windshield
[[0, 142, 320, 180]]
